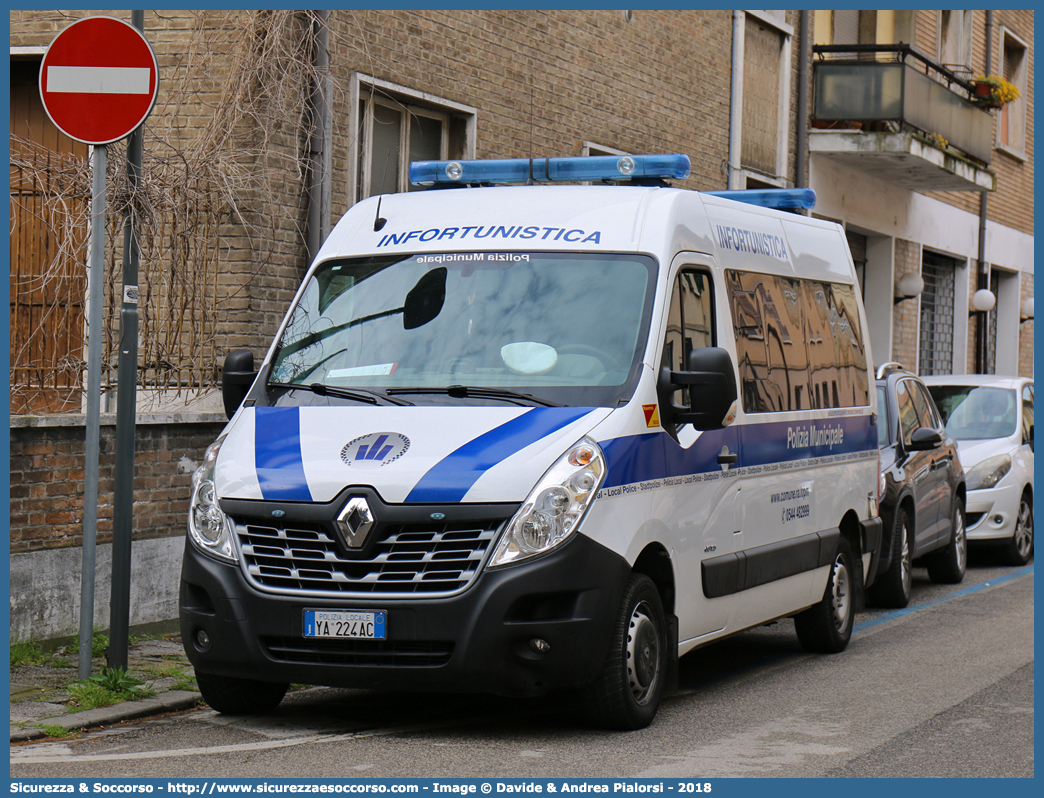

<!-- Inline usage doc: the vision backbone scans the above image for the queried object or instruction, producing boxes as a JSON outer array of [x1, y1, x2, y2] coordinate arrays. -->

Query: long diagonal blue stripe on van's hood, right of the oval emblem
[[406, 407, 591, 504]]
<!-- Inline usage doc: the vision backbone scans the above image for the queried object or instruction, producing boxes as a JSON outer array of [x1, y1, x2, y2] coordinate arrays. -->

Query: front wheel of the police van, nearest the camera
[[584, 573, 663, 730]]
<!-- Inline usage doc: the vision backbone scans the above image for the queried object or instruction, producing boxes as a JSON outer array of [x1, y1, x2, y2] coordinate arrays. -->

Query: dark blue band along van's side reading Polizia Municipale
[[601, 416, 877, 489]]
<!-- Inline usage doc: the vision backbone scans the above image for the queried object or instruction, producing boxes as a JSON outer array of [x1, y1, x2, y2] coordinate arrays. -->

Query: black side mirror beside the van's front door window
[[661, 347, 738, 429]]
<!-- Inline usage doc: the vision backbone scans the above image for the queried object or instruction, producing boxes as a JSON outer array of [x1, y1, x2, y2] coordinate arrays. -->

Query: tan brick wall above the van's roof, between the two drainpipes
[[330, 10, 732, 220]]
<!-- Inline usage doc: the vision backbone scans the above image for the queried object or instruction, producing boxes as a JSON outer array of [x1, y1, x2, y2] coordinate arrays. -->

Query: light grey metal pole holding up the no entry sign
[[78, 144, 109, 679]]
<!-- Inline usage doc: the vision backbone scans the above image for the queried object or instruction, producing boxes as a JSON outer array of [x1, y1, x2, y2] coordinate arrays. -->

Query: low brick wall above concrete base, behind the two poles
[[10, 416, 223, 553]]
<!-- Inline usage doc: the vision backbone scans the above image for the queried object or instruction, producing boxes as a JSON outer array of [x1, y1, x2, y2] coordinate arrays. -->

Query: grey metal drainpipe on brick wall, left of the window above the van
[[306, 10, 330, 264]]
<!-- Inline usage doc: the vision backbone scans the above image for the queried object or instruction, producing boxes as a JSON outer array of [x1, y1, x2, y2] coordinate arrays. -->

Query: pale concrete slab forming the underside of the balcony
[[808, 131, 997, 192]]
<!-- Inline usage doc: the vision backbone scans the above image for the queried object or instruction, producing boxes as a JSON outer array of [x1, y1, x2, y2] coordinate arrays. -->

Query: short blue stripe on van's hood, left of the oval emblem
[[254, 407, 312, 501]]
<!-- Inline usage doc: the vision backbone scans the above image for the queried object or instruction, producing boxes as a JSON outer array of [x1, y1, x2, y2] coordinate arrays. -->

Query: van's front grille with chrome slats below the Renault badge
[[236, 519, 503, 597]]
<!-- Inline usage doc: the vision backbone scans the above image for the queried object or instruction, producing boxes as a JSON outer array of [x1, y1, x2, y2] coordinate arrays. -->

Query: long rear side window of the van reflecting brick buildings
[[726, 269, 870, 413]]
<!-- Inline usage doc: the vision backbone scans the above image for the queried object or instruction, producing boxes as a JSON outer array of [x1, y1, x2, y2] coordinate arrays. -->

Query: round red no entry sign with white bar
[[40, 17, 160, 144]]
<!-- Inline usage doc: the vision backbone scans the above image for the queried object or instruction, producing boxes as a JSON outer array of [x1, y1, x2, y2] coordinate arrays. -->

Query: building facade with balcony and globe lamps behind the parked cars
[[809, 10, 1034, 376]]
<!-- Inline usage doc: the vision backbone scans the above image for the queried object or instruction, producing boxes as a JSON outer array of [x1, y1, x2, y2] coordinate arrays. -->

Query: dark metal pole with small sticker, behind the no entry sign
[[106, 11, 145, 671]]
